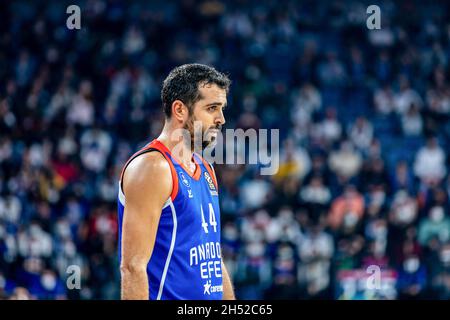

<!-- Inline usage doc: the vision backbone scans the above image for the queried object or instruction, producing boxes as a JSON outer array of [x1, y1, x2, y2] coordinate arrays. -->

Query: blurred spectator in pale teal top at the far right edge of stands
[[419, 206, 450, 245]]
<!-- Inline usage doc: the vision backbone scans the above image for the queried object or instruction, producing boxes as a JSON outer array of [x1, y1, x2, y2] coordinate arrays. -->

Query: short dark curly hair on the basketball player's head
[[161, 63, 231, 118]]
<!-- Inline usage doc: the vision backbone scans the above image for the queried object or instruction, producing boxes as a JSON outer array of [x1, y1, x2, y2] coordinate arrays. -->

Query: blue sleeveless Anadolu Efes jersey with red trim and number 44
[[118, 140, 223, 300]]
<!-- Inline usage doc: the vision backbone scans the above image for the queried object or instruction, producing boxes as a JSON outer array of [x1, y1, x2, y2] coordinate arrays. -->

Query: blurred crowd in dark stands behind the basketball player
[[0, 0, 450, 299]]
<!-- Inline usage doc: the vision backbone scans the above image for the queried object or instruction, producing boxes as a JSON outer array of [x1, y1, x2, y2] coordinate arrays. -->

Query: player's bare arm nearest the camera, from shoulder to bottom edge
[[120, 152, 172, 300]]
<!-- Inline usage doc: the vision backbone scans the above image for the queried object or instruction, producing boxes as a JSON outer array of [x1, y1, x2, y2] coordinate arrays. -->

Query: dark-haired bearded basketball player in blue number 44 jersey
[[118, 64, 235, 300]]
